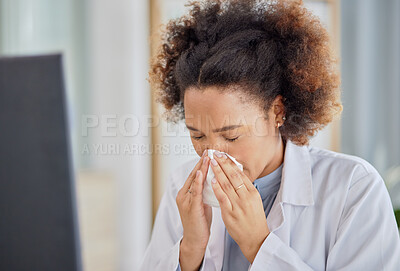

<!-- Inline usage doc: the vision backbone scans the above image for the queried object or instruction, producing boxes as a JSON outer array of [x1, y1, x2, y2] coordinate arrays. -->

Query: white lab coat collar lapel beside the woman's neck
[[276, 140, 314, 206]]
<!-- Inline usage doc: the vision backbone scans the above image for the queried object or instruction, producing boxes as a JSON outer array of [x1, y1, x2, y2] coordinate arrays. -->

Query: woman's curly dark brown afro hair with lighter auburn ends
[[149, 0, 343, 145]]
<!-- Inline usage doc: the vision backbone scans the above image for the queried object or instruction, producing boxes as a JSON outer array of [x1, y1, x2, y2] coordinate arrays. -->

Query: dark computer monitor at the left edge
[[0, 54, 81, 271]]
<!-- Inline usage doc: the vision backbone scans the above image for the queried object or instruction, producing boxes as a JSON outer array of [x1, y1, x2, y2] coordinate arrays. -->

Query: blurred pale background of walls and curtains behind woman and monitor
[[0, 0, 400, 271]]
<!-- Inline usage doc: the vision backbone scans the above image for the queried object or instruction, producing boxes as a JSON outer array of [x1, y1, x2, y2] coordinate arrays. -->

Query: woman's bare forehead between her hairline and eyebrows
[[184, 87, 263, 126]]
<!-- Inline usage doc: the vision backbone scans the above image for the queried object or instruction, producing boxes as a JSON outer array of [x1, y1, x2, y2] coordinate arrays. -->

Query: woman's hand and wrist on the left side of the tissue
[[176, 151, 212, 270]]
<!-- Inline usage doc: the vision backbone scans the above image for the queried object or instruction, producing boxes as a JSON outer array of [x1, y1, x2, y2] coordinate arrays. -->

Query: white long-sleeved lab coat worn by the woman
[[139, 141, 400, 271]]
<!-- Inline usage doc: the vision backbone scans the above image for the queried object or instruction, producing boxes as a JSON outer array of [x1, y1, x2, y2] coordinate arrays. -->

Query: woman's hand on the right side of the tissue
[[211, 152, 270, 263]]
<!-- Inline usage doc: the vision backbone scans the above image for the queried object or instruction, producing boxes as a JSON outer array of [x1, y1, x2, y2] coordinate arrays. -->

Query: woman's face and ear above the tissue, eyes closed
[[184, 87, 285, 182]]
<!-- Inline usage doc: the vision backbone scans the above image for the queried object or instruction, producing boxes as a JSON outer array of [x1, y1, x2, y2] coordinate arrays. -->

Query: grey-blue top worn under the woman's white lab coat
[[222, 163, 283, 271]]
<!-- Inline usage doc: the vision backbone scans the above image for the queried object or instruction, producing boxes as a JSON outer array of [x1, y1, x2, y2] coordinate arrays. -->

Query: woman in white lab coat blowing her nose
[[140, 0, 400, 271]]
